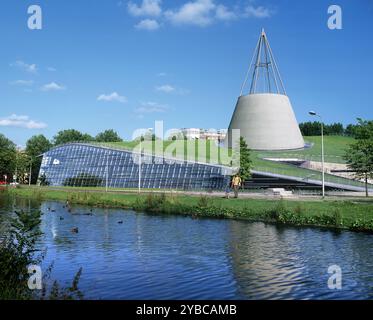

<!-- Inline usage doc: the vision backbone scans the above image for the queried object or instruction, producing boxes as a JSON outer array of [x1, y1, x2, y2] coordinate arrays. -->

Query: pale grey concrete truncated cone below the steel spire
[[228, 93, 304, 150]]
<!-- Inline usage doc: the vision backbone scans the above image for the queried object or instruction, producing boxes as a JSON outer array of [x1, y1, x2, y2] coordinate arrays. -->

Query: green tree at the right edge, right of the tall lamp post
[[345, 119, 373, 197]]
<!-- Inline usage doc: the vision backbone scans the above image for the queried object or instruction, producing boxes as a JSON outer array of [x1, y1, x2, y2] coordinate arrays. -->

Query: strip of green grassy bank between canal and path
[[2, 187, 373, 232]]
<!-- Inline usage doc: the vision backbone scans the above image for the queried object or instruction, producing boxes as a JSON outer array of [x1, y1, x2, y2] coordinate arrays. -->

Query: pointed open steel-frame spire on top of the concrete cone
[[240, 28, 286, 96]]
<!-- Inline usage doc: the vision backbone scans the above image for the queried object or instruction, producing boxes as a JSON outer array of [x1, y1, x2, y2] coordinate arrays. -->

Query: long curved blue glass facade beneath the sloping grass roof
[[39, 143, 231, 190]]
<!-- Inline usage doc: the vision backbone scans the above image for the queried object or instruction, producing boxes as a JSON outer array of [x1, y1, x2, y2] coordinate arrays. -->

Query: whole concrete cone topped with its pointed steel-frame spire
[[225, 30, 304, 150]]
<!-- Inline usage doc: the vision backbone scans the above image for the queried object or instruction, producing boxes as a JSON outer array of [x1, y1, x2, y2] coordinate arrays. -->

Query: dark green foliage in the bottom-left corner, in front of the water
[[0, 211, 83, 300]]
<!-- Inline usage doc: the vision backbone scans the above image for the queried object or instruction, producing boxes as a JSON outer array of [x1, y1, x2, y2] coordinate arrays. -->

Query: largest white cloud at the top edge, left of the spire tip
[[165, 0, 216, 27]]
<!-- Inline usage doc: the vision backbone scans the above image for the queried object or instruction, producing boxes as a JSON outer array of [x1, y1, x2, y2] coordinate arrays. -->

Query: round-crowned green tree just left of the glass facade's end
[[26, 134, 52, 184]]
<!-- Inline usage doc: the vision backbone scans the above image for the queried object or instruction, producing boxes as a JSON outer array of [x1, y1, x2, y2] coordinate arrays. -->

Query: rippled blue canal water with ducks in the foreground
[[0, 195, 373, 299]]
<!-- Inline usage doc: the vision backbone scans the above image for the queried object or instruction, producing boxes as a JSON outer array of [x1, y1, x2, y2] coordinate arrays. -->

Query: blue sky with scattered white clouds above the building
[[0, 0, 373, 145]]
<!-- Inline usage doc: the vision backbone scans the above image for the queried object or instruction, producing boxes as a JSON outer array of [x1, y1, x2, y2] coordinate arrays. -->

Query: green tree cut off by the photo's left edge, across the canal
[[0, 133, 16, 182]]
